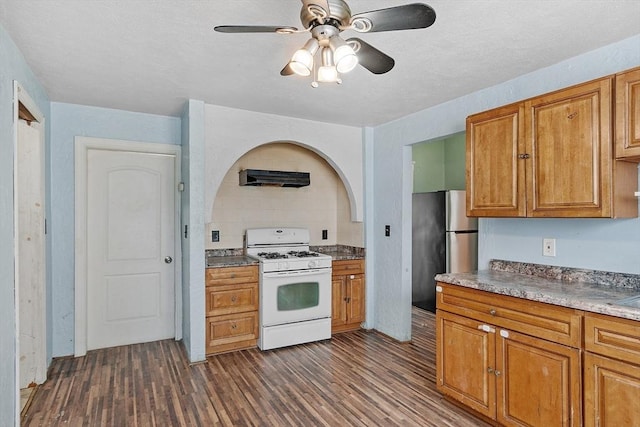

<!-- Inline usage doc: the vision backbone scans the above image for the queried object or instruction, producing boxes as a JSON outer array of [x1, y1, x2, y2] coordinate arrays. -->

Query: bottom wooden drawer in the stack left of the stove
[[206, 311, 258, 354]]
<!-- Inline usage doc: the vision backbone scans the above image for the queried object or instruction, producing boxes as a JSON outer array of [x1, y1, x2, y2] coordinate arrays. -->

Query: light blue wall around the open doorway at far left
[[0, 26, 50, 425]]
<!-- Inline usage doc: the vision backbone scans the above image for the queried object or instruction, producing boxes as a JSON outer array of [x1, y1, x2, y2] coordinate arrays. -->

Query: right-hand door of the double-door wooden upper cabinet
[[525, 78, 613, 217]]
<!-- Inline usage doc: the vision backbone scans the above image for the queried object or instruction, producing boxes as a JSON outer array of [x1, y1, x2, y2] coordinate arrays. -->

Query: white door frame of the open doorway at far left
[[13, 80, 47, 425]]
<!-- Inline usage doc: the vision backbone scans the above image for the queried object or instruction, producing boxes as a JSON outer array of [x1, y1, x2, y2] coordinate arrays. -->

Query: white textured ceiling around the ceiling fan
[[0, 0, 640, 126]]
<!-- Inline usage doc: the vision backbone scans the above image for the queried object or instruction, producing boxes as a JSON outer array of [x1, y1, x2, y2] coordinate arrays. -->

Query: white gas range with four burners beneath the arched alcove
[[245, 228, 332, 350]]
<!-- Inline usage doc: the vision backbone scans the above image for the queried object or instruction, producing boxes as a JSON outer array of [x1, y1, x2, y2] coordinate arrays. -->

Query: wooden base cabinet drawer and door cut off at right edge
[[584, 313, 640, 427]]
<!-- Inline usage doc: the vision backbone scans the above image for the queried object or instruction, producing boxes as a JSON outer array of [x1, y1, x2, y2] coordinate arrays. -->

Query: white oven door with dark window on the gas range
[[260, 268, 331, 327]]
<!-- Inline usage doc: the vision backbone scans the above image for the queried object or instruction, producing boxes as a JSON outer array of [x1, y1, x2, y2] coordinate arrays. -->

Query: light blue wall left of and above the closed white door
[[49, 102, 181, 357]]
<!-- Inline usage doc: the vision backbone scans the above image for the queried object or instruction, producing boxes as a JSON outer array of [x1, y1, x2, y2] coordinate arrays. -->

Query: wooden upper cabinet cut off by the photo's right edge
[[615, 67, 640, 161]]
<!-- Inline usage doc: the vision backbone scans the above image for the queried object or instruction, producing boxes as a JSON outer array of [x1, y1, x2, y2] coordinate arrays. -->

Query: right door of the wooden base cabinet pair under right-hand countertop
[[495, 329, 581, 427]]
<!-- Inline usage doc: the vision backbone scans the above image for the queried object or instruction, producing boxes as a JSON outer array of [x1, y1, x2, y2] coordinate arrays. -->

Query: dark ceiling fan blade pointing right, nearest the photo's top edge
[[351, 3, 436, 33]]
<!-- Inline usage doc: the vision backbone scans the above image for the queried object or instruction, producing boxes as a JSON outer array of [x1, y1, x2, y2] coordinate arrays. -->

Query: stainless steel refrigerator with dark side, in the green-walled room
[[411, 190, 478, 312]]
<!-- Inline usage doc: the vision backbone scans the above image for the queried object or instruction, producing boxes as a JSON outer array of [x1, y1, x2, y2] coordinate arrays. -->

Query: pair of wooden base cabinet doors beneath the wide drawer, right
[[436, 311, 581, 427]]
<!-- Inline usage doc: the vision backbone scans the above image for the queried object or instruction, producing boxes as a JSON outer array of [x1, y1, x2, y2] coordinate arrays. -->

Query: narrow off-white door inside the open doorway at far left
[[16, 120, 46, 388]]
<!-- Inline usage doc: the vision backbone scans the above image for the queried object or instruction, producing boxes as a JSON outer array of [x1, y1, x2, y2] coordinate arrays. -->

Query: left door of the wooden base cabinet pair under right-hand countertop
[[436, 310, 496, 419]]
